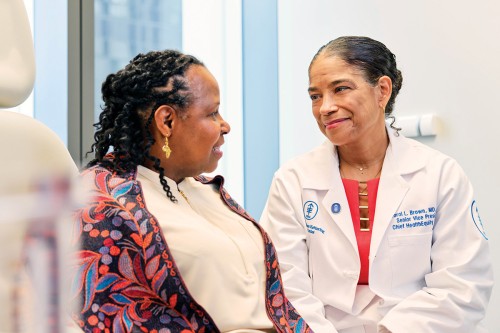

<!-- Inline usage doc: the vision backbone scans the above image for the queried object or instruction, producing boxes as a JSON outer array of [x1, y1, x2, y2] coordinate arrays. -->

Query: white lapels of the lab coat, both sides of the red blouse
[[300, 127, 429, 255]]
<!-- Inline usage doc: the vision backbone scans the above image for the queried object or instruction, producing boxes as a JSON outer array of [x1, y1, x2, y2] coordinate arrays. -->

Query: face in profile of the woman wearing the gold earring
[[155, 65, 230, 181]]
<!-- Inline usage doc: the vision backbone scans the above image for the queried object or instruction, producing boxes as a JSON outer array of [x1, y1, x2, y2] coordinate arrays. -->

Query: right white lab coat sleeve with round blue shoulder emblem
[[380, 160, 493, 333]]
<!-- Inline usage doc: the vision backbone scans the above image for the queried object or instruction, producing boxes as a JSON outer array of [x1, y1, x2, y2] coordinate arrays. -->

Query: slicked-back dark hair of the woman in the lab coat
[[309, 36, 403, 130]]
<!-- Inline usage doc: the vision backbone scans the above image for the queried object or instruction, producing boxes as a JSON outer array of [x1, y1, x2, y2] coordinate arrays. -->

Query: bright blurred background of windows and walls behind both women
[[0, 0, 500, 332]]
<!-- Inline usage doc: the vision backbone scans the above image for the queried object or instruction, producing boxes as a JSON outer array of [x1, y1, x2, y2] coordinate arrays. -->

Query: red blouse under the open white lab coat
[[342, 178, 380, 284]]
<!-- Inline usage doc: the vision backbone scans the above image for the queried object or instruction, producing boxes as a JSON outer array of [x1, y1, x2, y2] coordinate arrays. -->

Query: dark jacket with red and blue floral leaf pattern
[[72, 166, 312, 333]]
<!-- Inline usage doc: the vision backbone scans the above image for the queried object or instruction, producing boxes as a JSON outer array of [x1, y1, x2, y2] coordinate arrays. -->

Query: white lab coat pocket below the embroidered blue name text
[[388, 232, 432, 296]]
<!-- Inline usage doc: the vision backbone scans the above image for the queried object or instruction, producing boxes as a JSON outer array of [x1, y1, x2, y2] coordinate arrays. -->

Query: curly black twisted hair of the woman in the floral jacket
[[86, 50, 204, 202]]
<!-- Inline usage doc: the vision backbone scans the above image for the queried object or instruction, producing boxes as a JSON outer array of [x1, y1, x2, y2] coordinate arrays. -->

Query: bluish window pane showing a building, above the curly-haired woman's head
[[94, 0, 182, 120]]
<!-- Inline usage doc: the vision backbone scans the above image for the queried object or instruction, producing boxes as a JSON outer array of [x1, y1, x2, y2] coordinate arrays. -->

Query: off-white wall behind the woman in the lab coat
[[278, 0, 500, 333]]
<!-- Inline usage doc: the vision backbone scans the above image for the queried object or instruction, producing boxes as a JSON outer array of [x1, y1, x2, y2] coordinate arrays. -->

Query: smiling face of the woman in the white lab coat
[[308, 55, 392, 146]]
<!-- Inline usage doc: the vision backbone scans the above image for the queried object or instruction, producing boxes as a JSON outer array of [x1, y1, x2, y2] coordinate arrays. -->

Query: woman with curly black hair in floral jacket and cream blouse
[[73, 50, 310, 332]]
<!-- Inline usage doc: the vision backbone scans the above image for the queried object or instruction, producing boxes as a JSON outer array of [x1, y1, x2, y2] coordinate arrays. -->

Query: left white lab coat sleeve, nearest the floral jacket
[[260, 171, 337, 333]]
